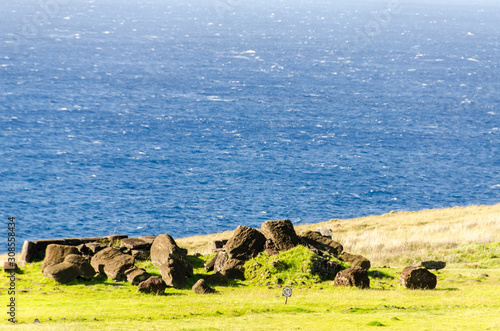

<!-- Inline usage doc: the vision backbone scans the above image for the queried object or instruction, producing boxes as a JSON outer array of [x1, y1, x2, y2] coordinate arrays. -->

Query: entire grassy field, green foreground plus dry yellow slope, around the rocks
[[0, 205, 500, 330]]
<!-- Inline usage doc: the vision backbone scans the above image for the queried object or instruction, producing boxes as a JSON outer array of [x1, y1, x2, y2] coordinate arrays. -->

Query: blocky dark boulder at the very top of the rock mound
[[260, 220, 300, 251]]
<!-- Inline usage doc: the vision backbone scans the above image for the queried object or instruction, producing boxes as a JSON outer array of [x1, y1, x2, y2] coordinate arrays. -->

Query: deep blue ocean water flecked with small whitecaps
[[0, 0, 500, 250]]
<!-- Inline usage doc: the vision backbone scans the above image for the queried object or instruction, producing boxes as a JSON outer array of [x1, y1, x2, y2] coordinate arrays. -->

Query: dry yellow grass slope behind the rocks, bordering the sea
[[176, 204, 500, 265]]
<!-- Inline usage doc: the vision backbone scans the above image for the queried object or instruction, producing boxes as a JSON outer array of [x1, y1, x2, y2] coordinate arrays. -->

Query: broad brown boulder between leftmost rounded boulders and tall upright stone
[[90, 247, 135, 282]]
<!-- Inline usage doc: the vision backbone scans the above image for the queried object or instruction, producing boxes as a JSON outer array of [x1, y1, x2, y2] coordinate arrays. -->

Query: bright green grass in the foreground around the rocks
[[0, 249, 500, 330]]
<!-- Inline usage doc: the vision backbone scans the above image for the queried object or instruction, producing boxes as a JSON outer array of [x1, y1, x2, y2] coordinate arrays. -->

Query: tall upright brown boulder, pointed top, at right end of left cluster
[[151, 234, 193, 288]]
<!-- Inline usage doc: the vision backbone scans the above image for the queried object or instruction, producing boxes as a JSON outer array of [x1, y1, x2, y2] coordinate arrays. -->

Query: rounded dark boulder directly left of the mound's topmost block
[[225, 225, 266, 260]]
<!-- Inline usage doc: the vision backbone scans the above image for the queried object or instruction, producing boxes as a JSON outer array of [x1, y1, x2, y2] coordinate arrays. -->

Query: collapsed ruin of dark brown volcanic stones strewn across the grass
[[22, 219, 446, 293]]
